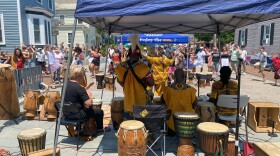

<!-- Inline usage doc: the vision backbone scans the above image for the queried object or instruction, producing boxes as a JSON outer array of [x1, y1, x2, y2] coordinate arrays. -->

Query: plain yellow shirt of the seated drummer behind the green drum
[[162, 86, 196, 131]]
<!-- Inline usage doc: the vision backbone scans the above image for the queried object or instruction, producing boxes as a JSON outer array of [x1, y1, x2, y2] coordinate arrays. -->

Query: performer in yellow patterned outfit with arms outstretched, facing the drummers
[[143, 47, 174, 96]]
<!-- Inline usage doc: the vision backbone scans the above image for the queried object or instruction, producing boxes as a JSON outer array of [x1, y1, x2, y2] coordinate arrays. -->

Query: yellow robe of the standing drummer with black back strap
[[115, 62, 150, 112]]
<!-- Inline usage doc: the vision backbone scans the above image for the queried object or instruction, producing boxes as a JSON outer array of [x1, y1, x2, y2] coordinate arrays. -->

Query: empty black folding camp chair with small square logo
[[133, 105, 170, 156]]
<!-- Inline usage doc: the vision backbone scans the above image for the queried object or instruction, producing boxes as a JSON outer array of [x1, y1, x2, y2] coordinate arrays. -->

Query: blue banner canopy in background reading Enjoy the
[[116, 34, 189, 44]]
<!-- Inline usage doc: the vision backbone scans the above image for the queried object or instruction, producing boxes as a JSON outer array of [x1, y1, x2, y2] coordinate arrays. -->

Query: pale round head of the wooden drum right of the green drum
[[197, 122, 229, 133]]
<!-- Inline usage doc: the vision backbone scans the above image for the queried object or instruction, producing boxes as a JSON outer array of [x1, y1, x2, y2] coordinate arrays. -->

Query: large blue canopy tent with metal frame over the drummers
[[54, 0, 280, 155]]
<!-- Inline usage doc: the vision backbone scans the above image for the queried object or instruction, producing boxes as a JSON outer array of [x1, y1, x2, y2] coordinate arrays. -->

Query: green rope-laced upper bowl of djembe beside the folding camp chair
[[173, 112, 199, 138]]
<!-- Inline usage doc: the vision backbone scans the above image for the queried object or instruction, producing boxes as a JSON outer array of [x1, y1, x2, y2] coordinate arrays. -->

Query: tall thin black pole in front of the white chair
[[235, 58, 243, 156]]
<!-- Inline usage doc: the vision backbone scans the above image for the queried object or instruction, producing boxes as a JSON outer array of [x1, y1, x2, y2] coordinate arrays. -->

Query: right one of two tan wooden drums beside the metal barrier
[[44, 91, 60, 120]]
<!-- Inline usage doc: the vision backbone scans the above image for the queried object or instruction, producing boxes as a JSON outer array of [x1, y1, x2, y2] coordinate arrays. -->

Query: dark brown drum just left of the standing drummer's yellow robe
[[111, 97, 124, 130]]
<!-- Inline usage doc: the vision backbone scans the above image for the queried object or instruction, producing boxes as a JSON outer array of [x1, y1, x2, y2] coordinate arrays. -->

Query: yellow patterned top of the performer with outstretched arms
[[147, 56, 174, 84]]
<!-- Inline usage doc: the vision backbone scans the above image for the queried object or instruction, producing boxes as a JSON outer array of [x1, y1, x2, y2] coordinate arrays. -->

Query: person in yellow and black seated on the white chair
[[209, 66, 238, 125]]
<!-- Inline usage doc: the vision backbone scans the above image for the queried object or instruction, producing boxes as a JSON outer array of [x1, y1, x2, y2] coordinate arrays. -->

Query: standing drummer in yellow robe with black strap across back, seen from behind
[[115, 45, 154, 119]]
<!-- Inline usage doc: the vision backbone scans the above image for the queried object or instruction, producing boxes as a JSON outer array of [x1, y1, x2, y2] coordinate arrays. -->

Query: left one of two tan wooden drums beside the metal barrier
[[23, 90, 42, 118]]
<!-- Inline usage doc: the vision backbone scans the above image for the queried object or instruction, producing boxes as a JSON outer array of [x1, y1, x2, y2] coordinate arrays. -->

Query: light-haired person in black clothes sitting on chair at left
[[64, 66, 109, 136]]
